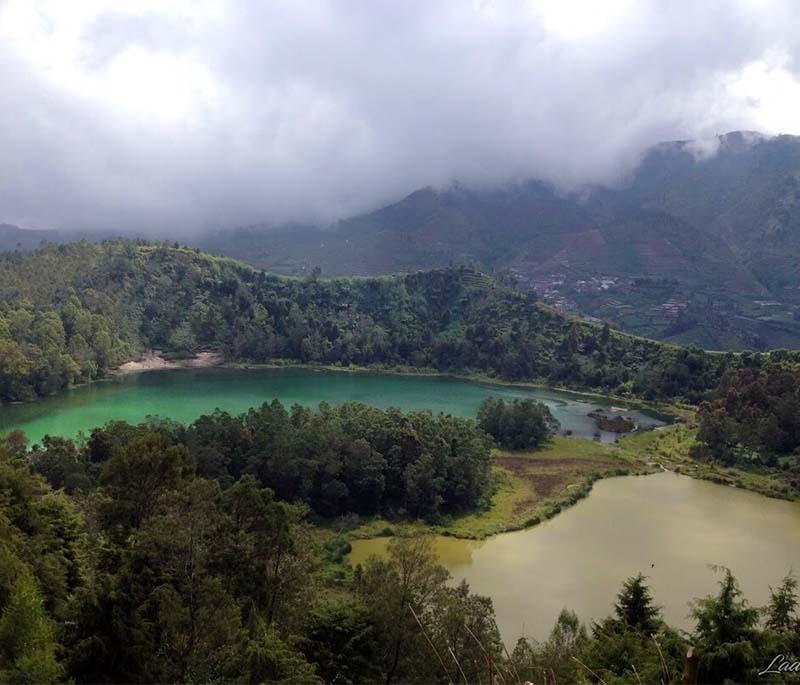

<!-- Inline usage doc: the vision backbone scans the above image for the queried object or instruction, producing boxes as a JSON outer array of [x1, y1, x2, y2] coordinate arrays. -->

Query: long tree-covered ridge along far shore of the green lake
[[0, 241, 792, 402]]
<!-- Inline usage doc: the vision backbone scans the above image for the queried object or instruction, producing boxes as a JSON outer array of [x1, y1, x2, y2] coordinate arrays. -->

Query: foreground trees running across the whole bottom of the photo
[[0, 420, 800, 685]]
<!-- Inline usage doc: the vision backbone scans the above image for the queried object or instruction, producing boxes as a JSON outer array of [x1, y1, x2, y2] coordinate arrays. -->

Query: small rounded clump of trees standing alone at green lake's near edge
[[478, 397, 559, 450]]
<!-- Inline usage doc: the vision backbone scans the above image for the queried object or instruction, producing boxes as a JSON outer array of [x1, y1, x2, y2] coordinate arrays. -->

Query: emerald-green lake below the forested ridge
[[0, 367, 661, 443]]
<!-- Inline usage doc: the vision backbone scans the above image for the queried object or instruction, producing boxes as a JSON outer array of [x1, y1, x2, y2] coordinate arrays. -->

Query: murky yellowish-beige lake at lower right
[[350, 473, 800, 649]]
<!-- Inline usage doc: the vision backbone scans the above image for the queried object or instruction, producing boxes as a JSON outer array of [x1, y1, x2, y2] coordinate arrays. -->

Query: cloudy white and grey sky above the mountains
[[0, 0, 800, 233]]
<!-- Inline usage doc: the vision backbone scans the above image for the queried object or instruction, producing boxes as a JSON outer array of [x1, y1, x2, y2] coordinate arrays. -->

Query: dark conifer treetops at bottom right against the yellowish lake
[[511, 569, 800, 685]]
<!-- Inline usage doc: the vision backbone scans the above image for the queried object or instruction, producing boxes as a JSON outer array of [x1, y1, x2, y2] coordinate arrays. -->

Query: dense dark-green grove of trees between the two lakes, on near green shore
[[36, 400, 491, 519]]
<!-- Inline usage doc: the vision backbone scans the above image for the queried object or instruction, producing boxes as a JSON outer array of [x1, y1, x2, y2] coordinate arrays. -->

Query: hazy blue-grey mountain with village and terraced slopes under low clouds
[[197, 132, 800, 349]]
